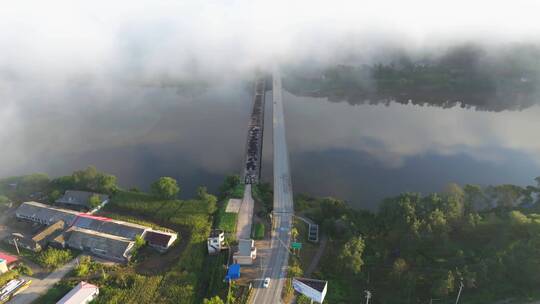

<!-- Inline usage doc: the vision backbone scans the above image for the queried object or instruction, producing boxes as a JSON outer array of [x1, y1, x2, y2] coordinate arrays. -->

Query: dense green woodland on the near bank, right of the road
[[295, 179, 540, 303]]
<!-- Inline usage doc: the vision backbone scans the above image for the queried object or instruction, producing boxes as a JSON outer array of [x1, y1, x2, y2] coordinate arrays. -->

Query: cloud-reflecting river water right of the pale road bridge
[[276, 94, 540, 207]]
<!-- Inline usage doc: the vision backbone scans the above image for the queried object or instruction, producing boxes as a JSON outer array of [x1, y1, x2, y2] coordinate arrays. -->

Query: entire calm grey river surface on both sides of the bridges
[[0, 80, 540, 207]]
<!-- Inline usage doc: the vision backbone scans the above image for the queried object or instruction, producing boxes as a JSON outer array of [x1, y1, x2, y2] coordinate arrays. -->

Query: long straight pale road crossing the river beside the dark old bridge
[[251, 68, 293, 304]]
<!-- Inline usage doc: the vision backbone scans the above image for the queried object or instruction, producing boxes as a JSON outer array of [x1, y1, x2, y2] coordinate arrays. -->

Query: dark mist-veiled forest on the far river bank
[[283, 45, 540, 111]]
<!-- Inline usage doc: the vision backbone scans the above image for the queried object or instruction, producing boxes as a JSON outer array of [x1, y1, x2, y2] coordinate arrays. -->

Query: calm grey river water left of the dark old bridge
[[0, 81, 251, 196]]
